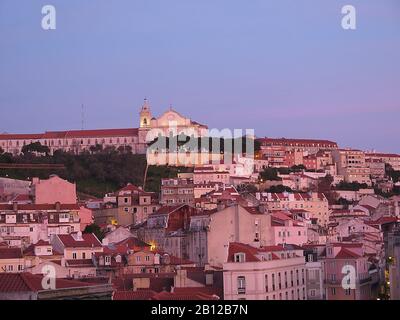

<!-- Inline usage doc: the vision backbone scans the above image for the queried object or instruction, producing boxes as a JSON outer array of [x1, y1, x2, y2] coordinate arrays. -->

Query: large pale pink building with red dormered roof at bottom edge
[[223, 242, 307, 300]]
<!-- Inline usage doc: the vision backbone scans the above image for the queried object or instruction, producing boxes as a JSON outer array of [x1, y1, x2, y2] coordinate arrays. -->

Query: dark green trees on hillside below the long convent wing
[[0, 144, 187, 197]]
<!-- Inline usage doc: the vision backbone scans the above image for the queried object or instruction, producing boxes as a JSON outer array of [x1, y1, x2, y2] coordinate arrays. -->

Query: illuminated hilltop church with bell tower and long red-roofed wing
[[0, 100, 208, 155]]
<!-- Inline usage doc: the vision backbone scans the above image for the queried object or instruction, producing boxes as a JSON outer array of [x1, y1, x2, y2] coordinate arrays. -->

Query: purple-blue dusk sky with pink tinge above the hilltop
[[0, 0, 400, 153]]
